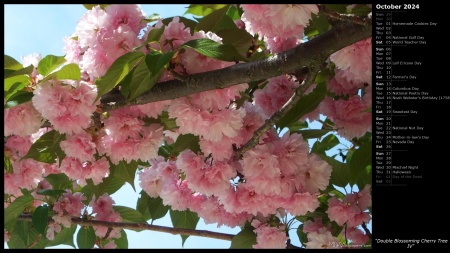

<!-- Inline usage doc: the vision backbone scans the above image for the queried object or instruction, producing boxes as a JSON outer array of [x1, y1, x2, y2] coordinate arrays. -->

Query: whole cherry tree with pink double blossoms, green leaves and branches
[[4, 4, 372, 248]]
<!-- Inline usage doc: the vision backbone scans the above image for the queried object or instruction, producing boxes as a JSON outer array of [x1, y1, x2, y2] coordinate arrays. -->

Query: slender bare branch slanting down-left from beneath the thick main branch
[[235, 67, 320, 160]]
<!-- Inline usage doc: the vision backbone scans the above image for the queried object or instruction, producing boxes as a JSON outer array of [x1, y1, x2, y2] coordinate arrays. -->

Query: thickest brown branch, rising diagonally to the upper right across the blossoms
[[100, 19, 372, 111]]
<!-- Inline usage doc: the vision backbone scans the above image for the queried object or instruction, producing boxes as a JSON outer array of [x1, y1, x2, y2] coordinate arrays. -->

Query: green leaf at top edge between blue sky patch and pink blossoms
[[196, 5, 237, 33]]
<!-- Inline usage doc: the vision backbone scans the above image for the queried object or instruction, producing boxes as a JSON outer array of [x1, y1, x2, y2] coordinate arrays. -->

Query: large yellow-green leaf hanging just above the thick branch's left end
[[95, 51, 144, 101]]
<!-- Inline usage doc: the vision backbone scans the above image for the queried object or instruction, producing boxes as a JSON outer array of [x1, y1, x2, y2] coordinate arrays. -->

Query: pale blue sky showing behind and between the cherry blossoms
[[4, 4, 371, 249]]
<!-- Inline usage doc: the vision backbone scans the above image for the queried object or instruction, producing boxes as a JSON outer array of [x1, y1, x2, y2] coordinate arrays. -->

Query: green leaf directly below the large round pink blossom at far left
[[22, 130, 66, 164]]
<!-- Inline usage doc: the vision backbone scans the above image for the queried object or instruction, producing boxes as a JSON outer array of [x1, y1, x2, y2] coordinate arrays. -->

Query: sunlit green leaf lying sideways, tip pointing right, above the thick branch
[[180, 38, 247, 61]]
